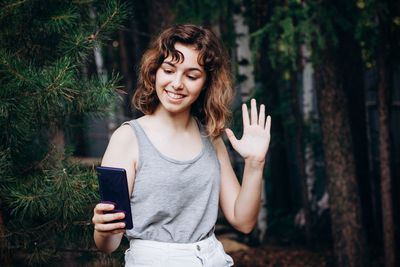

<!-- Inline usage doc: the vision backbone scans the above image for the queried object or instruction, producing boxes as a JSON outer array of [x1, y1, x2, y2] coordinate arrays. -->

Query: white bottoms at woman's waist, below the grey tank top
[[125, 234, 233, 267]]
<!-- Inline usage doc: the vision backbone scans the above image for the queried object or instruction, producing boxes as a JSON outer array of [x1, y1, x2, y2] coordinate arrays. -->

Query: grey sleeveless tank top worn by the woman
[[124, 120, 220, 243]]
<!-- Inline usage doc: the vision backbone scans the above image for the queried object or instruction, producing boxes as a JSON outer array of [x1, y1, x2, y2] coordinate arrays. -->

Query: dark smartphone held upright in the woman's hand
[[97, 166, 133, 229]]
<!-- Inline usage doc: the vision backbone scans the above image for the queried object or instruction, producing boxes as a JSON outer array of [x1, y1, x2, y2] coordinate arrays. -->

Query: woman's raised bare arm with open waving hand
[[214, 99, 271, 233]]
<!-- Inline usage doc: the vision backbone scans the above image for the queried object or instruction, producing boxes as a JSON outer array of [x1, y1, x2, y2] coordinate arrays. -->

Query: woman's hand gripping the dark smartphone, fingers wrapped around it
[[92, 203, 125, 236]]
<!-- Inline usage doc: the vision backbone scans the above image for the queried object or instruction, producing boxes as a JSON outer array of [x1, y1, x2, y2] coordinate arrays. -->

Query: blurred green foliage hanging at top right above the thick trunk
[[251, 0, 358, 72]]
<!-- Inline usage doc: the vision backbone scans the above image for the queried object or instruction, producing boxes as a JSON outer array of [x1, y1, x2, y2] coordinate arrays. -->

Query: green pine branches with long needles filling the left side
[[0, 0, 128, 265]]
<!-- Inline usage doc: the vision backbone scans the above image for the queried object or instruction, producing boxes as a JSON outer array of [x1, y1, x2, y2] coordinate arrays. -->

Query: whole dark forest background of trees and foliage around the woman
[[0, 0, 400, 267]]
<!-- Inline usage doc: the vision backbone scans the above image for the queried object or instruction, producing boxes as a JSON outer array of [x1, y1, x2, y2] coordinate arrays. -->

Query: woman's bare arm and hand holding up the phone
[[92, 125, 138, 253]]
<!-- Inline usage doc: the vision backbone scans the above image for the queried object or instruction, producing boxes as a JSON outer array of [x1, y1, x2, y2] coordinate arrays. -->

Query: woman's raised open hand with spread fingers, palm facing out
[[225, 99, 271, 163]]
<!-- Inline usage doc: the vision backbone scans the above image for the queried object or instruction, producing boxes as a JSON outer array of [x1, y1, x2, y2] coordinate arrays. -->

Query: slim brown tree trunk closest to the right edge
[[377, 31, 396, 267]]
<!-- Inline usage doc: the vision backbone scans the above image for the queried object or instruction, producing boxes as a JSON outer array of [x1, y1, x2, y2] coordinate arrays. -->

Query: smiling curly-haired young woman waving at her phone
[[93, 24, 271, 267]]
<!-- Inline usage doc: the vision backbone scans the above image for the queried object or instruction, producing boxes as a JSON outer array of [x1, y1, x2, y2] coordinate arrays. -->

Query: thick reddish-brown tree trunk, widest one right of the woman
[[315, 52, 367, 267]]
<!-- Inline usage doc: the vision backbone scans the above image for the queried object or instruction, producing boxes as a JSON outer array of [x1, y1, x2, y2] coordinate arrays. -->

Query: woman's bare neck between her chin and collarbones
[[152, 106, 192, 130]]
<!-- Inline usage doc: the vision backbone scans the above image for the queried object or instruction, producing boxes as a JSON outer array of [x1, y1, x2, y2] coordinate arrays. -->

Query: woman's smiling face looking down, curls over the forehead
[[155, 43, 206, 113]]
